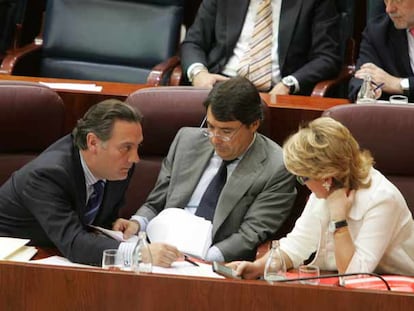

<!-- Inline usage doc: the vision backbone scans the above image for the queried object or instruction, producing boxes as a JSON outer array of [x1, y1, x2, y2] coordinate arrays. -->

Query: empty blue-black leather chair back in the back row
[[40, 0, 183, 83]]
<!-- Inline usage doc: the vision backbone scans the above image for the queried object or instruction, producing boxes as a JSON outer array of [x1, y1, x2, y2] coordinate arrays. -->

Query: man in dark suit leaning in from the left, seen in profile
[[0, 100, 177, 265]]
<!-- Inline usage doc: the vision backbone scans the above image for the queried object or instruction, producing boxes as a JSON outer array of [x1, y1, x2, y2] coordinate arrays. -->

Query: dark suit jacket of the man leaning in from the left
[[0, 135, 132, 265]]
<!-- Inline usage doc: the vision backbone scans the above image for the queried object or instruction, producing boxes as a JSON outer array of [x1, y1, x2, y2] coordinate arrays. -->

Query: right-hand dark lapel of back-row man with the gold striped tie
[[278, 0, 304, 68]]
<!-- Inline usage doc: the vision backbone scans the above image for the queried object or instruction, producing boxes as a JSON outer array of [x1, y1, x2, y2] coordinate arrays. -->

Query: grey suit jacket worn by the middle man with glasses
[[136, 128, 296, 261]]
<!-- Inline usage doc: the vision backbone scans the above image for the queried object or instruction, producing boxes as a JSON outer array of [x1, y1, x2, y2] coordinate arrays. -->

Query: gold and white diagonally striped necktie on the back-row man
[[238, 0, 272, 91]]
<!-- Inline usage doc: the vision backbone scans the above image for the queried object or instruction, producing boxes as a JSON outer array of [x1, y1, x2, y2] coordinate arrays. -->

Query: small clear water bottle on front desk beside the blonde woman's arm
[[264, 240, 286, 284]]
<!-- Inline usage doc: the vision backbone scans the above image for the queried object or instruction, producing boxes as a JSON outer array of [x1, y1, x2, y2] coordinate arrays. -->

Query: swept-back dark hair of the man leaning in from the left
[[72, 99, 142, 150]]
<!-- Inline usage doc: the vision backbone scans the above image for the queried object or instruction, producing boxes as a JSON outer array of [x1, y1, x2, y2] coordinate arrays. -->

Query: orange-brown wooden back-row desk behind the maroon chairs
[[0, 75, 349, 145]]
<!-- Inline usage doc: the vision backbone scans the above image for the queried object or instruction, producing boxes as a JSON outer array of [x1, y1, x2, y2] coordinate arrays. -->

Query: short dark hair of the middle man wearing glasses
[[203, 77, 263, 125]]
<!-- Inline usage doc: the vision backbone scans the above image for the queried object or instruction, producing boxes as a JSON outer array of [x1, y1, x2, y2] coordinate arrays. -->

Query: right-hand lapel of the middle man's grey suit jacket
[[213, 137, 267, 237]]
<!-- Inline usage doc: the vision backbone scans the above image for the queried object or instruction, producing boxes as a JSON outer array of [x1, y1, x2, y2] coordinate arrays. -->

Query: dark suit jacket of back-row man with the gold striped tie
[[181, 0, 341, 95]]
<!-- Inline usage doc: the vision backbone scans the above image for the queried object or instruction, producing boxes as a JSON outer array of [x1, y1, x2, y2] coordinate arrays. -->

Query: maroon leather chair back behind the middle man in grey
[[120, 86, 269, 218]]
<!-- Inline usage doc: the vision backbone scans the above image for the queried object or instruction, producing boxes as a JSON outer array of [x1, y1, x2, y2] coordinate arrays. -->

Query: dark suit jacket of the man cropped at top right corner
[[349, 14, 414, 101]]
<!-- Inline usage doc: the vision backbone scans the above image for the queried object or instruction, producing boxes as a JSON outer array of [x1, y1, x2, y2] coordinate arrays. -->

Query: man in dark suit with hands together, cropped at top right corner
[[349, 0, 414, 101]]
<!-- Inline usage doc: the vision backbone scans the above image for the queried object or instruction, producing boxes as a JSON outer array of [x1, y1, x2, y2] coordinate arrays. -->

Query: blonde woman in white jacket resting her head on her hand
[[229, 118, 414, 279]]
